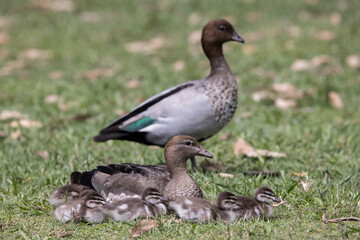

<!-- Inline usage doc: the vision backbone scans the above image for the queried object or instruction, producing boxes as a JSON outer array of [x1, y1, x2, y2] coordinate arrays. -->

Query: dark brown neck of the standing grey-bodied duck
[[201, 41, 231, 76]]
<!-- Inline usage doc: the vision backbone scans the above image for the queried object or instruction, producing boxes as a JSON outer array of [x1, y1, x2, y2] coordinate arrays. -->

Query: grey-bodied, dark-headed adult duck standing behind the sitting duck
[[93, 19, 244, 167]]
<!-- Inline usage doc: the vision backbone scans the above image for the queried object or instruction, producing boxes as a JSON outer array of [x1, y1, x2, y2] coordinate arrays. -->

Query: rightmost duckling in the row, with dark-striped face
[[237, 187, 280, 220]]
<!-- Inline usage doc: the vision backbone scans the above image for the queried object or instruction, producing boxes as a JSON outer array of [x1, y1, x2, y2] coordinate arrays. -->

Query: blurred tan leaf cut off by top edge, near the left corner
[[34, 0, 76, 12]]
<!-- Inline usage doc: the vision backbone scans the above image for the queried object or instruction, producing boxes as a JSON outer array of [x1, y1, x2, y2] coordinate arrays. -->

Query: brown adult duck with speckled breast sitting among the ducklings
[[81, 135, 212, 200]]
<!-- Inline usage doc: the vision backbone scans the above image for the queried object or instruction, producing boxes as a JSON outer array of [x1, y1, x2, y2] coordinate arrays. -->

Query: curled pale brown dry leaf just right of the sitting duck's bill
[[233, 138, 287, 158]]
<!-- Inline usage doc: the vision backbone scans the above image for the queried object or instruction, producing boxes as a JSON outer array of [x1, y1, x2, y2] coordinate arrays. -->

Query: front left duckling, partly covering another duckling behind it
[[54, 189, 107, 223]]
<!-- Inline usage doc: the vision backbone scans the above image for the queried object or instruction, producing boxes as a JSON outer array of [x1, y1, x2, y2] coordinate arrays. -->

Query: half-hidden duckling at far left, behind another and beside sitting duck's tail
[[49, 172, 86, 207]]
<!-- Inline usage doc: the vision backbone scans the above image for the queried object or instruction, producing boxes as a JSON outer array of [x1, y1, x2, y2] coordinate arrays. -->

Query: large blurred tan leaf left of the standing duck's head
[[125, 37, 170, 54]]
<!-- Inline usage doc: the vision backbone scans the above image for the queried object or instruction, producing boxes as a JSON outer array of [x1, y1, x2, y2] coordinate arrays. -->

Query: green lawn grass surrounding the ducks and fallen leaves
[[0, 0, 360, 239]]
